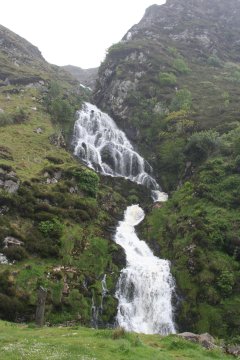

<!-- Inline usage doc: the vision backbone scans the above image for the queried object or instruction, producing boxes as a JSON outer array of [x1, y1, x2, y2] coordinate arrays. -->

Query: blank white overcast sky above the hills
[[0, 0, 165, 68]]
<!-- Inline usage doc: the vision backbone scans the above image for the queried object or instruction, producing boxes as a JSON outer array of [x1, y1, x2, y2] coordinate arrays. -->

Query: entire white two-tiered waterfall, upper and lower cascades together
[[73, 103, 175, 335]]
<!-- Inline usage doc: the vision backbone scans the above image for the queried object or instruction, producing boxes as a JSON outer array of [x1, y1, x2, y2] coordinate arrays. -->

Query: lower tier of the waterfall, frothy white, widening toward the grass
[[115, 205, 175, 335]]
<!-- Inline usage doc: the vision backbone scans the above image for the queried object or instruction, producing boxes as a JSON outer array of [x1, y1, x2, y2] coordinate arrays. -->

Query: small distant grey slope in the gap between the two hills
[[62, 65, 98, 89]]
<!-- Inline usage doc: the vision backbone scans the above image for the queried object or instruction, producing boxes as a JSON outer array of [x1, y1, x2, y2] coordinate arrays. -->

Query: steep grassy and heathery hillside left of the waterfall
[[0, 22, 150, 325]]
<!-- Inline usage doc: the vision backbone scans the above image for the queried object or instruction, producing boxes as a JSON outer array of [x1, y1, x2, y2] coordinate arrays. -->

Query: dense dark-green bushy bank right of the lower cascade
[[144, 128, 240, 338]]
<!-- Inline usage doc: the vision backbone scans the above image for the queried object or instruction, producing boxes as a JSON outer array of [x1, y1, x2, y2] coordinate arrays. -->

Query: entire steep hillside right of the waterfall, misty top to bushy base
[[94, 0, 240, 339]]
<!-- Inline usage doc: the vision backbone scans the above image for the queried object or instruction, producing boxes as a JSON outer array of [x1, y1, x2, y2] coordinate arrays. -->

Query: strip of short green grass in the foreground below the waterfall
[[0, 321, 231, 360]]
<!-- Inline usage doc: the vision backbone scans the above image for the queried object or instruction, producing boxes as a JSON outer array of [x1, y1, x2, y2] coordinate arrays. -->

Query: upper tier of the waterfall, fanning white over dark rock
[[73, 103, 167, 201]]
